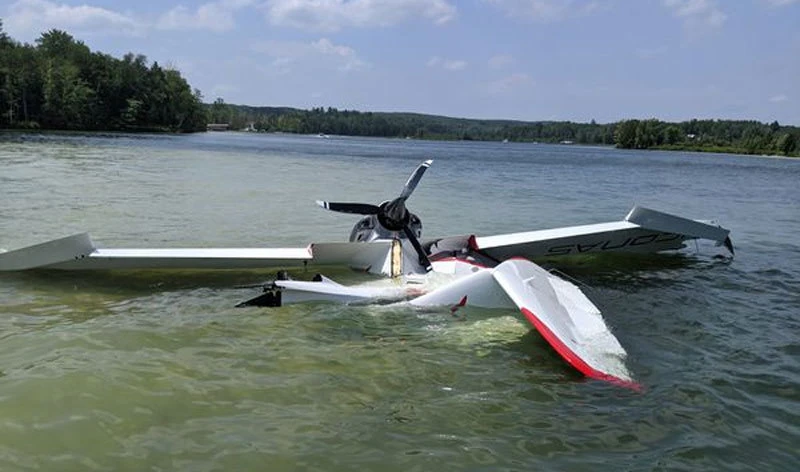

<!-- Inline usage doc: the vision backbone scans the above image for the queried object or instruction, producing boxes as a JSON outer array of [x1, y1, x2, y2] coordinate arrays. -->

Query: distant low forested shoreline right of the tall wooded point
[[209, 99, 800, 156]]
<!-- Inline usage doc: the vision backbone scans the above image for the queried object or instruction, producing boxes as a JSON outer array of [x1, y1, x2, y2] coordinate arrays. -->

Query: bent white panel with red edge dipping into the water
[[410, 259, 640, 389]]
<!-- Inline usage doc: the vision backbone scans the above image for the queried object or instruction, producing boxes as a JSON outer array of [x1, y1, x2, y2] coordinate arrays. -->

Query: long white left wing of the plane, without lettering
[[0, 233, 399, 274]]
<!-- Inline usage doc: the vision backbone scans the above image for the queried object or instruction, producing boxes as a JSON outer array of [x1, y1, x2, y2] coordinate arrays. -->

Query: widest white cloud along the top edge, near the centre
[[264, 0, 456, 32]]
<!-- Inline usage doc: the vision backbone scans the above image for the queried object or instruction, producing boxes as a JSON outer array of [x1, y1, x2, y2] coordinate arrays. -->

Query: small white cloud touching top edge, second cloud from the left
[[156, 0, 253, 32]]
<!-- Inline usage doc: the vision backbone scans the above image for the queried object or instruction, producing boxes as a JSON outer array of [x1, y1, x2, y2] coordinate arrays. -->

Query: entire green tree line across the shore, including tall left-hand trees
[[0, 20, 800, 156]]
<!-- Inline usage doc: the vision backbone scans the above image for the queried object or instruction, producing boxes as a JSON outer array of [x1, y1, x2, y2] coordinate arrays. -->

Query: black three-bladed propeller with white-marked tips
[[317, 159, 433, 271]]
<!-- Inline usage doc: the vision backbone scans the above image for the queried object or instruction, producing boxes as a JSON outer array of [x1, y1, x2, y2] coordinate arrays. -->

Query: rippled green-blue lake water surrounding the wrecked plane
[[0, 133, 800, 472]]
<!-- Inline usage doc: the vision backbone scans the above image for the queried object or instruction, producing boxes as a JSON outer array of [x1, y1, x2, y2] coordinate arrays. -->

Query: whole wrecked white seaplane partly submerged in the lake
[[0, 160, 733, 387]]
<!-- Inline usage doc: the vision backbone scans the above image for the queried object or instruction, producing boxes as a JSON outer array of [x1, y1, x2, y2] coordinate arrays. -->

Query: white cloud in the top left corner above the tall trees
[[3, 0, 145, 41]]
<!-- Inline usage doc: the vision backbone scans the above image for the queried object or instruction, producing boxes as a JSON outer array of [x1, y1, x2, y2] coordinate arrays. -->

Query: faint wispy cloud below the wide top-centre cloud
[[250, 38, 367, 73]]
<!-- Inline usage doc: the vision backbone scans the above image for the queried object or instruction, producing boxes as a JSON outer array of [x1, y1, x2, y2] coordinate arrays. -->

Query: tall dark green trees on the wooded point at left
[[0, 21, 207, 131]]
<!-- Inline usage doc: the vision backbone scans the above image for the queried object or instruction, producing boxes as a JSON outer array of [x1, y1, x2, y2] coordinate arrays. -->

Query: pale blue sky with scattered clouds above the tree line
[[0, 0, 800, 125]]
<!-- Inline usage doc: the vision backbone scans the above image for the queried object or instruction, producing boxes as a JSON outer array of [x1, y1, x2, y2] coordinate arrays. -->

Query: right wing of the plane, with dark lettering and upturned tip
[[427, 206, 734, 261]]
